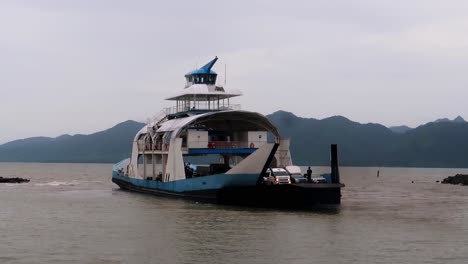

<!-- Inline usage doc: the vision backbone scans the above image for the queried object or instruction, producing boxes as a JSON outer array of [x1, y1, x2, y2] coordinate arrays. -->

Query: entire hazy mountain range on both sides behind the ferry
[[0, 111, 468, 168]]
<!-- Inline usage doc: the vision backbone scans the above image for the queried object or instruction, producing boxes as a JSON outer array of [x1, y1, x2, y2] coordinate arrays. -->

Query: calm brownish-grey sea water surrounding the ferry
[[0, 163, 468, 264]]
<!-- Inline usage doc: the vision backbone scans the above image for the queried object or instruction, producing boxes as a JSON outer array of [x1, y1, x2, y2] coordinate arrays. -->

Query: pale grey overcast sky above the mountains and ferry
[[0, 0, 468, 143]]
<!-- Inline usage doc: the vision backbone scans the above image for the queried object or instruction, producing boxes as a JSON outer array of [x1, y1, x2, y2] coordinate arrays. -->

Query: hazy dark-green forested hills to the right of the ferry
[[268, 111, 468, 168]]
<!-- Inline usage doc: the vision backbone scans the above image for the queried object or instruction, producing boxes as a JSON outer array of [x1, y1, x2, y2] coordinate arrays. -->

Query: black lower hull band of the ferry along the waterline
[[112, 178, 344, 208]]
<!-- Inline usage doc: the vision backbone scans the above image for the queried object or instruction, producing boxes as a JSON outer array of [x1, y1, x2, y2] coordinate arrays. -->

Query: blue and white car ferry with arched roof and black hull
[[112, 57, 344, 208]]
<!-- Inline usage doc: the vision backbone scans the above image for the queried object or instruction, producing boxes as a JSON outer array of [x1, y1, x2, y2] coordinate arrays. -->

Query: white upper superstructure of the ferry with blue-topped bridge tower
[[135, 58, 279, 155]]
